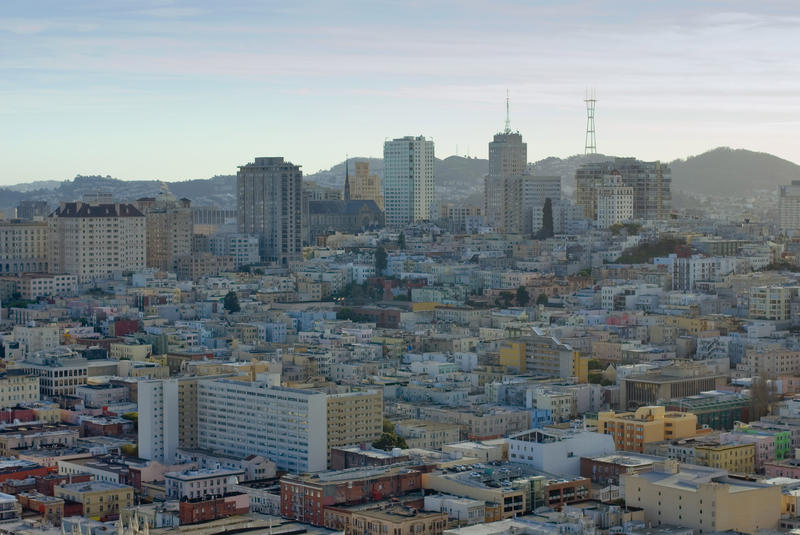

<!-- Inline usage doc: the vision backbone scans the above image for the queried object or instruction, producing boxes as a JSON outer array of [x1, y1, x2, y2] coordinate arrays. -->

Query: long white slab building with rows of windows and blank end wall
[[197, 379, 328, 473]]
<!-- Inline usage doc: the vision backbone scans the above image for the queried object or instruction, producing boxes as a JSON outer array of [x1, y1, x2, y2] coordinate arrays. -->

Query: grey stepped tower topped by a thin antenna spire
[[484, 132, 528, 229]]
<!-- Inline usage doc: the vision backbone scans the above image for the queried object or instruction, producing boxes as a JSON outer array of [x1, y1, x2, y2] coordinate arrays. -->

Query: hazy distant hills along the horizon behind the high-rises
[[0, 147, 800, 216]]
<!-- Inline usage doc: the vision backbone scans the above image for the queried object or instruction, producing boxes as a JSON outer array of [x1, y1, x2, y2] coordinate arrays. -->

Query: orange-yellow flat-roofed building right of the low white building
[[597, 407, 697, 453]]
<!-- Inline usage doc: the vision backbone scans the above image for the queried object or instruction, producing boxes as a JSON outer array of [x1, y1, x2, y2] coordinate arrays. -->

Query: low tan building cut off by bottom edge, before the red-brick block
[[352, 504, 447, 535]]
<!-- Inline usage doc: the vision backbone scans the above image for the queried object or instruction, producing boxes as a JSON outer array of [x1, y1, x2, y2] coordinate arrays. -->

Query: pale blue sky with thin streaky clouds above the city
[[0, 0, 800, 185]]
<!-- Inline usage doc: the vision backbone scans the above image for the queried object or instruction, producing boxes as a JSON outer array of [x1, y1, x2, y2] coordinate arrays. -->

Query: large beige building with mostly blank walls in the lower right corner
[[620, 461, 781, 533]]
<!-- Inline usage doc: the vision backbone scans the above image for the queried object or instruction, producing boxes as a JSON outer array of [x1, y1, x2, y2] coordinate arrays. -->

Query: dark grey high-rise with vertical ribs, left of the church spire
[[236, 157, 304, 264]]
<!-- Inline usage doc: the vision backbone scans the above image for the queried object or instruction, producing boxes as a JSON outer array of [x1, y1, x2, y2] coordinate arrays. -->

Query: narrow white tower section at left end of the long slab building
[[138, 380, 179, 464]]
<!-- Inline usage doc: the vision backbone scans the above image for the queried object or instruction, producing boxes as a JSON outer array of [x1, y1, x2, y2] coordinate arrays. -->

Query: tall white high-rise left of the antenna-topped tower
[[383, 136, 435, 228]]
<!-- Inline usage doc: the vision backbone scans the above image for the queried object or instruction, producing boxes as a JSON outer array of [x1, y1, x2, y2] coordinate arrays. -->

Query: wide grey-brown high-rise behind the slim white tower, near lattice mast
[[575, 158, 672, 220]]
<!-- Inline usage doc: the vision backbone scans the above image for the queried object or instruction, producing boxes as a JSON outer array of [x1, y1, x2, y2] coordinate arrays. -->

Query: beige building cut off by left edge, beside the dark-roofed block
[[0, 219, 49, 275]]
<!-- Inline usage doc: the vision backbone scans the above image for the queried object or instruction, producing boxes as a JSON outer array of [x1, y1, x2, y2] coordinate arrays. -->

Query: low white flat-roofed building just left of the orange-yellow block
[[508, 428, 614, 476]]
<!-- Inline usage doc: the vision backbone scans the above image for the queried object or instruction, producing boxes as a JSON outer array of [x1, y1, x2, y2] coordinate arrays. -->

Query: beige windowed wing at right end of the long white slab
[[327, 390, 383, 461]]
